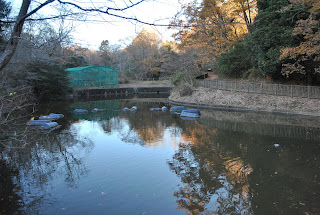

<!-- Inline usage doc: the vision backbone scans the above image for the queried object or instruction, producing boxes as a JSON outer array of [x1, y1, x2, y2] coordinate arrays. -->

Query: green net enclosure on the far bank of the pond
[[66, 66, 118, 88]]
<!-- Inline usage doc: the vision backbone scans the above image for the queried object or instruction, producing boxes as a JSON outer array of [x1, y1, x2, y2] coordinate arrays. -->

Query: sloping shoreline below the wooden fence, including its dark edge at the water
[[168, 87, 320, 117]]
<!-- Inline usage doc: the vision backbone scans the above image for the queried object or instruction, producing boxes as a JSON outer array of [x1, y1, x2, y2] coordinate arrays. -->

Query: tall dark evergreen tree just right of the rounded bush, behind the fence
[[250, 0, 297, 79]]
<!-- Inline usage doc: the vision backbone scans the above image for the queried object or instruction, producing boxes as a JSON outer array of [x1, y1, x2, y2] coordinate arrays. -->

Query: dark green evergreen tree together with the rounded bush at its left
[[219, 0, 298, 80]]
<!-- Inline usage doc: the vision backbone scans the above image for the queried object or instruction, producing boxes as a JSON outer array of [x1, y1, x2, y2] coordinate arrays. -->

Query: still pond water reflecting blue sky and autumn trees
[[0, 99, 320, 214]]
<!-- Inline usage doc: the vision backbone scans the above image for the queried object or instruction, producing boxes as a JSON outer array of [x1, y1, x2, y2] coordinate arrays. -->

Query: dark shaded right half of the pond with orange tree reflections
[[168, 113, 320, 214]]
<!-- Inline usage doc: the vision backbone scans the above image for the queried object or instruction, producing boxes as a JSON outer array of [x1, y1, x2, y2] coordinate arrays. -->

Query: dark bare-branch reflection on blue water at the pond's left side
[[0, 120, 93, 214]]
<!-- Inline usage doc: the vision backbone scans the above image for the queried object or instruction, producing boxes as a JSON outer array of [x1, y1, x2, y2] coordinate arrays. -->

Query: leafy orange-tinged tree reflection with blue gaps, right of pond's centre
[[168, 122, 253, 214]]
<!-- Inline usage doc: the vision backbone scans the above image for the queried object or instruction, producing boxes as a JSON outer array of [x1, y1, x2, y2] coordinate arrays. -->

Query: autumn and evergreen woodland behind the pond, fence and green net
[[0, 0, 320, 106]]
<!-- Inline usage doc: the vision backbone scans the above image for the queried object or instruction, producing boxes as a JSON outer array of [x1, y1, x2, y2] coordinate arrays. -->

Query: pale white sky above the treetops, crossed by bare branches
[[13, 0, 180, 49]]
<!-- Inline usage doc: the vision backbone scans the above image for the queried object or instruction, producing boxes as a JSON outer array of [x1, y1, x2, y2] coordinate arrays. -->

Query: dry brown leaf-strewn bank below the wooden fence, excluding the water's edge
[[169, 87, 320, 114]]
